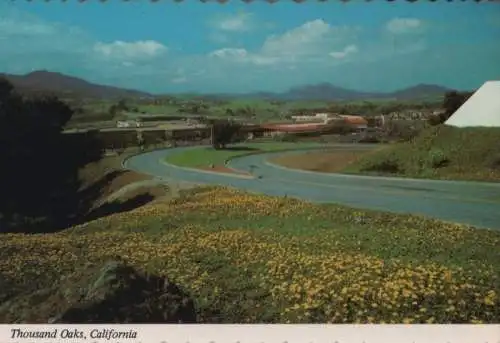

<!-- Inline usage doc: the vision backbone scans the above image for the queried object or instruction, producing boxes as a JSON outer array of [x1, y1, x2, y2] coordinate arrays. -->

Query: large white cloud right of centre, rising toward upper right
[[209, 19, 358, 65]]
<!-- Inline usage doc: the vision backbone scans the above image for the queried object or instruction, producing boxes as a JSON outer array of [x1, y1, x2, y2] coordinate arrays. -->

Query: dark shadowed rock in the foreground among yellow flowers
[[49, 261, 196, 323]]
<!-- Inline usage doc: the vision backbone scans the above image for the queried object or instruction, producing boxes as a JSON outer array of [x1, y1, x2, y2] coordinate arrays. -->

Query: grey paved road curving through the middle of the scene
[[124, 145, 500, 229]]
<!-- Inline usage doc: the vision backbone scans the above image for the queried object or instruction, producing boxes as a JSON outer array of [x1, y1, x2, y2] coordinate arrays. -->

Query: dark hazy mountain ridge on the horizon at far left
[[0, 70, 151, 99]]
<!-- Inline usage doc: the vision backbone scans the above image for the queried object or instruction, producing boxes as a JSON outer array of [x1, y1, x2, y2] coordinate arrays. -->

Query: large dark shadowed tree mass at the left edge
[[0, 79, 101, 232]]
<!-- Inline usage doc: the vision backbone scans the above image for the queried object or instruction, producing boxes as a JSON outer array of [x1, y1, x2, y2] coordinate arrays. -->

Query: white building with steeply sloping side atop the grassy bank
[[445, 81, 500, 127]]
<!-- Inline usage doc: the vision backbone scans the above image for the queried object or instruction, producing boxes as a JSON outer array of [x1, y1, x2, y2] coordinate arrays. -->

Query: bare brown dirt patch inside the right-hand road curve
[[269, 150, 369, 173]]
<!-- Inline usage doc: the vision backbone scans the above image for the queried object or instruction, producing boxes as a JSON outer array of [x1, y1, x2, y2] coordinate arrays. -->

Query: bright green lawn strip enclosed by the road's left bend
[[165, 142, 325, 168]]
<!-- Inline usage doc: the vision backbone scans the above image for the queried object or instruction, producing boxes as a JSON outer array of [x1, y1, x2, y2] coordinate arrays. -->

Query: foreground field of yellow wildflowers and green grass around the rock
[[0, 188, 500, 323]]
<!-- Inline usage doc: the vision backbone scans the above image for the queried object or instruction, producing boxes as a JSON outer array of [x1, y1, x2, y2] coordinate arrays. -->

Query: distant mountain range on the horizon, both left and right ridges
[[0, 70, 450, 101]]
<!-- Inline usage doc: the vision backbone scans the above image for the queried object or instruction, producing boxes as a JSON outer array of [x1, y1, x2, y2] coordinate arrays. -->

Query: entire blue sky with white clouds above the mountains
[[0, 0, 500, 93]]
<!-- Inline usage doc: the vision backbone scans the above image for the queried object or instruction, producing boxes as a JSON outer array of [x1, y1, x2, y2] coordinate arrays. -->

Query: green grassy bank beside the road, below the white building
[[343, 125, 500, 181]]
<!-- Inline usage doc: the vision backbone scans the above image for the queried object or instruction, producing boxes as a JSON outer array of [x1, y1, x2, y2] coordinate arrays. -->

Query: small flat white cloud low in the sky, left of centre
[[93, 40, 167, 59]]
